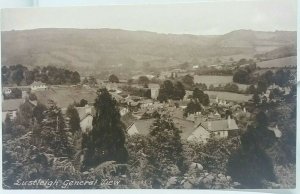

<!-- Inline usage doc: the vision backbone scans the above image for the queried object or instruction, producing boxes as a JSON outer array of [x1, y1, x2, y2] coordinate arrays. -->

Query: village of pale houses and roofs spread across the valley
[[2, 62, 291, 143]]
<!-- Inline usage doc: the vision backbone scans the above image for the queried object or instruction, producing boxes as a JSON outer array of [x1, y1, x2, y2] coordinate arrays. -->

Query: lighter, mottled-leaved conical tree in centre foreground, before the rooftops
[[146, 114, 185, 188]]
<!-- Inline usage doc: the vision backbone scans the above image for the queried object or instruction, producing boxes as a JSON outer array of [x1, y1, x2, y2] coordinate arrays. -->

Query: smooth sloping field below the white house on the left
[[34, 86, 96, 108]]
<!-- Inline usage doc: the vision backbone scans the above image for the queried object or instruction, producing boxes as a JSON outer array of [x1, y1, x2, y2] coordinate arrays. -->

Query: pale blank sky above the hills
[[1, 0, 297, 35]]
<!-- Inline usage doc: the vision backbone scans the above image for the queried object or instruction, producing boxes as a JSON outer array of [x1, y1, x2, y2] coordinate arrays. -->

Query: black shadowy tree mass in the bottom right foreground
[[228, 123, 276, 189]]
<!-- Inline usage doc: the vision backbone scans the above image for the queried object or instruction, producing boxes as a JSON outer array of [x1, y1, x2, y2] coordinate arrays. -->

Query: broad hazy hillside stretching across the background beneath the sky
[[2, 29, 296, 71]]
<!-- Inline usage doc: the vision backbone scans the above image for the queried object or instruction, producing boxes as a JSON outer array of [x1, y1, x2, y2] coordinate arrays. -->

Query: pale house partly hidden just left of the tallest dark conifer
[[76, 105, 95, 133]]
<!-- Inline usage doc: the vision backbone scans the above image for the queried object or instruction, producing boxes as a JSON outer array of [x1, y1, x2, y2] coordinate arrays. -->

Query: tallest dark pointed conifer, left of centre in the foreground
[[83, 88, 128, 168]]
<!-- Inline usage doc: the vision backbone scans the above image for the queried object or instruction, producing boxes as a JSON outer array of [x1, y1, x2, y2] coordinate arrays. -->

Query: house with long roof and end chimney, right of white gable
[[201, 116, 239, 138]]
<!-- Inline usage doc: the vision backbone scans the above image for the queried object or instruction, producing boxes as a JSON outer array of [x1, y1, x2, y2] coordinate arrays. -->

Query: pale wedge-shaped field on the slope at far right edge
[[257, 56, 297, 68]]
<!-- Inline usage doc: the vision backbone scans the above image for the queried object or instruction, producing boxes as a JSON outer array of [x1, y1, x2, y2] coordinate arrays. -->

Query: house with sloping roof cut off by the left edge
[[2, 99, 25, 122]]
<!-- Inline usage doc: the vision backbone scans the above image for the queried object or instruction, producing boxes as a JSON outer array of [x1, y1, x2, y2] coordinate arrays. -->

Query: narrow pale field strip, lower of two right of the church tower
[[204, 91, 252, 102]]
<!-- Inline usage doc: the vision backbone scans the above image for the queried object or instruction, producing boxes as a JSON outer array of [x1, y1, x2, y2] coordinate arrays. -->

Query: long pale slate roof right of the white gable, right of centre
[[201, 119, 239, 131]]
